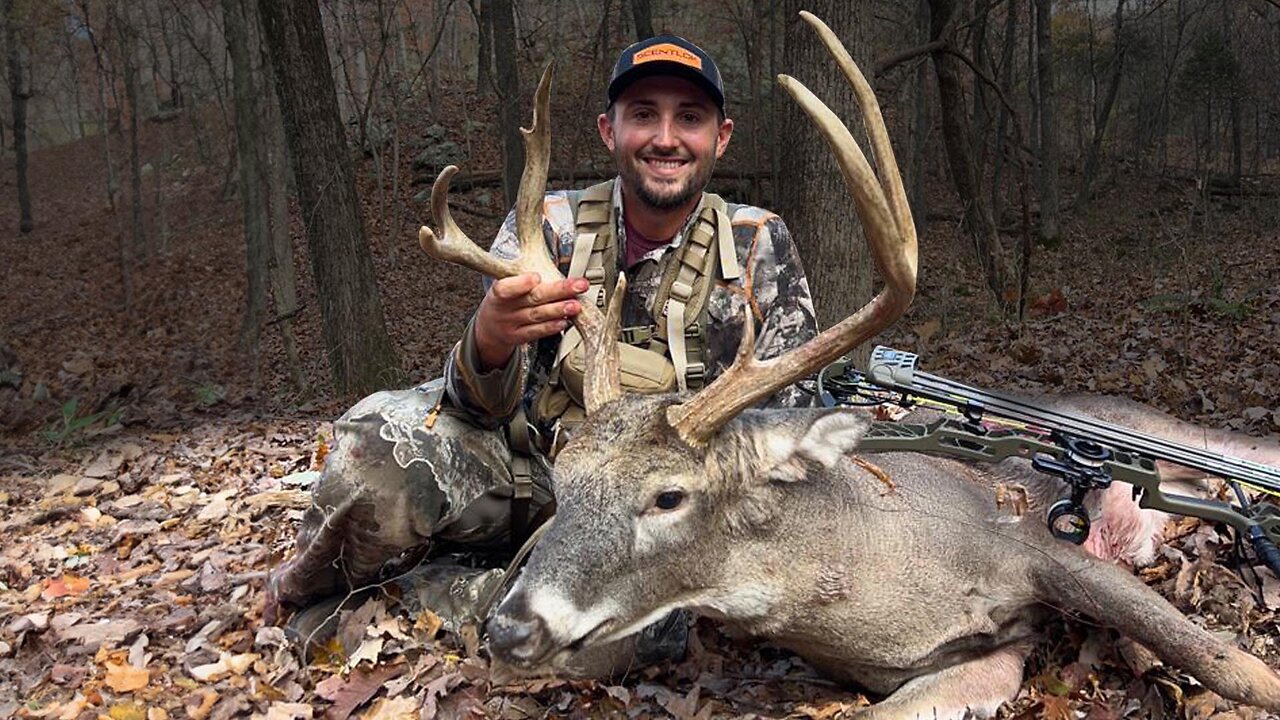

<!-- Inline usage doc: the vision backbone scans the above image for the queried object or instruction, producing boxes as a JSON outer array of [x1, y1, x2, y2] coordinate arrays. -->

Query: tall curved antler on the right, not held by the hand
[[667, 12, 916, 446]]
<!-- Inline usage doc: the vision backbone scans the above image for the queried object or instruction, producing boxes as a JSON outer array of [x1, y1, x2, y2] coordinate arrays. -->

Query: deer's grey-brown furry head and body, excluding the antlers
[[489, 397, 1280, 717]]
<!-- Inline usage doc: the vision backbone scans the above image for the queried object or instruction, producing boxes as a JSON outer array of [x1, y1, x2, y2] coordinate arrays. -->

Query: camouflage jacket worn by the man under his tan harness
[[444, 181, 817, 428]]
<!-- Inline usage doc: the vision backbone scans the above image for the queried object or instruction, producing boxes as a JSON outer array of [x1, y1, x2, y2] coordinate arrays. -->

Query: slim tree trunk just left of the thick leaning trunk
[[223, 0, 270, 389]]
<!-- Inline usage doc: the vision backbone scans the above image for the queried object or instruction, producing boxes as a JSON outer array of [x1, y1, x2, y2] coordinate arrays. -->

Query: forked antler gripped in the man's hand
[[417, 64, 623, 414]]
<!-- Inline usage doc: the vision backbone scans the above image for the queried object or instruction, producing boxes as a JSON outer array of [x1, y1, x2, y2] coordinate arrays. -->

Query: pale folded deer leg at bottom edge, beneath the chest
[[858, 643, 1030, 720]]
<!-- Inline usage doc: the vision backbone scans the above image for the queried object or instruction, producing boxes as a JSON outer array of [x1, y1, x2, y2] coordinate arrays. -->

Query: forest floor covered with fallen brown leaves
[[0, 92, 1280, 720]]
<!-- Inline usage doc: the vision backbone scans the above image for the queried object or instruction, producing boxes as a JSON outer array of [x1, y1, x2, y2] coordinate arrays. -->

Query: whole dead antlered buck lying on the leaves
[[419, 13, 1280, 719]]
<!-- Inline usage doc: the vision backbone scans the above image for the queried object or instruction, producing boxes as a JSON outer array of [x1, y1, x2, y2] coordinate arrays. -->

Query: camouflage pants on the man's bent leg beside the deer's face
[[265, 380, 552, 621]]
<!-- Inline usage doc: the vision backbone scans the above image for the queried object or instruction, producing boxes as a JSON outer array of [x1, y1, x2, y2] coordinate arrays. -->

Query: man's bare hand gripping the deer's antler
[[475, 273, 590, 372]]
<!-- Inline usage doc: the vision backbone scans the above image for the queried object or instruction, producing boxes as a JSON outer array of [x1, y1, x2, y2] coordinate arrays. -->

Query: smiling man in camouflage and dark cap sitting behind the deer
[[266, 36, 815, 671]]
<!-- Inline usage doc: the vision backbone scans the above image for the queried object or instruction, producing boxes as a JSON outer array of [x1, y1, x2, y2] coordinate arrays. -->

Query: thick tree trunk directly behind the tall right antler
[[774, 0, 872, 340]]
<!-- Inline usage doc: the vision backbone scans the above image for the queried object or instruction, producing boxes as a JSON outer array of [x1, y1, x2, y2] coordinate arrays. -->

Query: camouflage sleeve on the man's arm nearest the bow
[[750, 215, 818, 407]]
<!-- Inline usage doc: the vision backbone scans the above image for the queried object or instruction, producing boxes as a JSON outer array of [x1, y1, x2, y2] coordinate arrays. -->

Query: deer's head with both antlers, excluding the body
[[420, 13, 916, 666]]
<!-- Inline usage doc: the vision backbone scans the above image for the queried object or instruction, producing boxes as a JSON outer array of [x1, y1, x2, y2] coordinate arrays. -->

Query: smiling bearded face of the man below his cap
[[598, 76, 733, 210]]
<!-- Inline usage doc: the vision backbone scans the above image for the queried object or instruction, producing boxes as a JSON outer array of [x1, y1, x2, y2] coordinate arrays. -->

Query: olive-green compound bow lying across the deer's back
[[817, 346, 1280, 577]]
